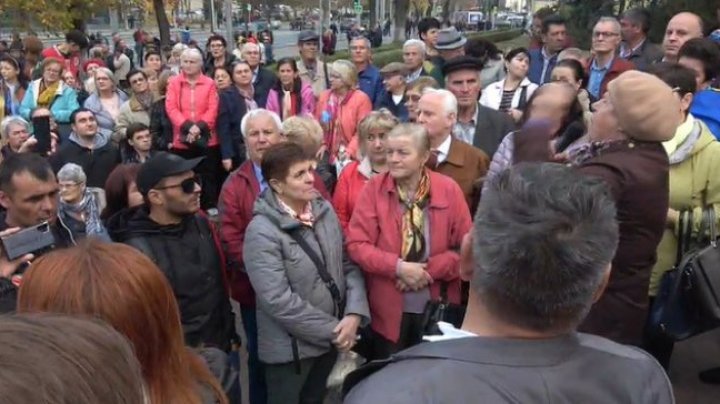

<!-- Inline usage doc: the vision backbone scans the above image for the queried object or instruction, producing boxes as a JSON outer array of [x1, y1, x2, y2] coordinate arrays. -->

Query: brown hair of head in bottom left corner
[[0, 314, 144, 404]]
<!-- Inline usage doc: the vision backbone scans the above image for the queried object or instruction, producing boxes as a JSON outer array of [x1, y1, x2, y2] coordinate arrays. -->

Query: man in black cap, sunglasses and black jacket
[[121, 152, 235, 352]]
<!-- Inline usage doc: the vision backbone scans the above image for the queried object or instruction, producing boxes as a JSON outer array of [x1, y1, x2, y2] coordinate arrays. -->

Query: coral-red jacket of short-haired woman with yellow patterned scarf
[[346, 172, 472, 342]]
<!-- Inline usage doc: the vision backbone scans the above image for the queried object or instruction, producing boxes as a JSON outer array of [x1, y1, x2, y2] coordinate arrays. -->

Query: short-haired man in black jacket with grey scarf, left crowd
[[51, 108, 121, 188]]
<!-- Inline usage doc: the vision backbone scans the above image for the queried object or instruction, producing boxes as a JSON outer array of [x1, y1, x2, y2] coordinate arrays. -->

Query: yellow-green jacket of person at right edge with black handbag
[[650, 120, 720, 296]]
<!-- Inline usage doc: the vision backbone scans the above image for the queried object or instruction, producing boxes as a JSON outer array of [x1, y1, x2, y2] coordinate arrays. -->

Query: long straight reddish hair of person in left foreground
[[18, 239, 227, 404]]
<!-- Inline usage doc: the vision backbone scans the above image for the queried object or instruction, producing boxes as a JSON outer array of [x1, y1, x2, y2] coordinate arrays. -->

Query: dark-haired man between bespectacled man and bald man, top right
[[618, 8, 663, 70]]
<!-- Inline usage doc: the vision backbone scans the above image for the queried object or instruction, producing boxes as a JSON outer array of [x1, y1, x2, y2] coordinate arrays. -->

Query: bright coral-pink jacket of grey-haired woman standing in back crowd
[[165, 73, 220, 149]]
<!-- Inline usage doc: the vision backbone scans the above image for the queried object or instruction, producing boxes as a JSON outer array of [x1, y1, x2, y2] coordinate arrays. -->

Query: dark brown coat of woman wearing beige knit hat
[[578, 141, 670, 345]]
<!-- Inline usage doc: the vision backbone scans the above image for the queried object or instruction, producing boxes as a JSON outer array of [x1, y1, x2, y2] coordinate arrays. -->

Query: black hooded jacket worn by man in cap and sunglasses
[[115, 206, 235, 351]]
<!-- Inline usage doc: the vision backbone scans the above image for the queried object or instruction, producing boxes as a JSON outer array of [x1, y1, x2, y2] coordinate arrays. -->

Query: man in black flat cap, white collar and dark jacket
[[443, 56, 515, 156]]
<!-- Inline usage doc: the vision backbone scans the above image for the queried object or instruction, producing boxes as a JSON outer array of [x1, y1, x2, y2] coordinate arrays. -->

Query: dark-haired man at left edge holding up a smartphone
[[0, 153, 74, 313]]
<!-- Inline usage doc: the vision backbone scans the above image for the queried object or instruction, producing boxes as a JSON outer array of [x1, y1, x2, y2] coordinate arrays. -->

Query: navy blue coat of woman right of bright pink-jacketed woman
[[215, 86, 248, 163]]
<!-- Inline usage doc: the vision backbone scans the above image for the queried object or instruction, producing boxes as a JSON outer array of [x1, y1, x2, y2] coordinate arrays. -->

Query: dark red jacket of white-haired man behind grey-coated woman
[[218, 160, 330, 307]]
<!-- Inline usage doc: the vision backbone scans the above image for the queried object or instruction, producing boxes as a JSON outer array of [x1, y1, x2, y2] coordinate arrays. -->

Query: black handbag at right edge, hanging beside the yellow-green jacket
[[649, 207, 720, 341]]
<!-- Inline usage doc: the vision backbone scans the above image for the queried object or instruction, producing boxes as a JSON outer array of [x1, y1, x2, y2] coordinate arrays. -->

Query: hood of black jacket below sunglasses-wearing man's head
[[121, 205, 193, 240]]
